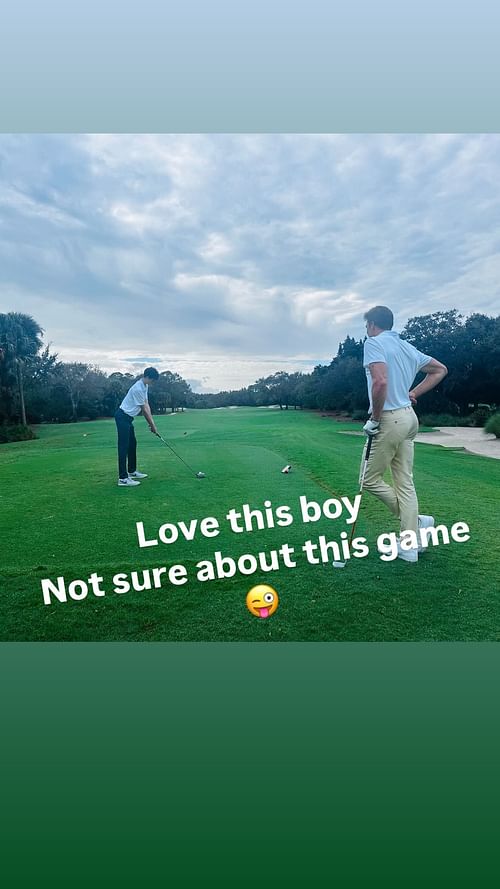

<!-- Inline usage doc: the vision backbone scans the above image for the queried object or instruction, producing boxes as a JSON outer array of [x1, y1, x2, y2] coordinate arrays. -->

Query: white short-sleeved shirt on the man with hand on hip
[[363, 330, 431, 411]]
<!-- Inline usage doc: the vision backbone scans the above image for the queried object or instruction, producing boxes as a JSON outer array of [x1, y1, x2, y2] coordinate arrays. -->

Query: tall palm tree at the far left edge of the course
[[0, 312, 43, 426]]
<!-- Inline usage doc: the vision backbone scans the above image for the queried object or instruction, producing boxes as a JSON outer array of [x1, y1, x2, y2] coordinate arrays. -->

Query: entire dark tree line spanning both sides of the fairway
[[0, 309, 500, 434]]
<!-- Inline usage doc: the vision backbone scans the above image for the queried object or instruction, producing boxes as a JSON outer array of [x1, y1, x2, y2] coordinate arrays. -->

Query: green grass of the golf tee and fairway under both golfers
[[0, 408, 500, 641]]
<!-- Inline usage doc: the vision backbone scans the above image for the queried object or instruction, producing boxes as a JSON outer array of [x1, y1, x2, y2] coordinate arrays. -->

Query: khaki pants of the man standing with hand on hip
[[359, 407, 418, 533]]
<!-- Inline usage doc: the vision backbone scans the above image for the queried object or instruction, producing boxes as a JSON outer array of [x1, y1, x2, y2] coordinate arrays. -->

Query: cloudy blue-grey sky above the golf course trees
[[0, 134, 500, 392]]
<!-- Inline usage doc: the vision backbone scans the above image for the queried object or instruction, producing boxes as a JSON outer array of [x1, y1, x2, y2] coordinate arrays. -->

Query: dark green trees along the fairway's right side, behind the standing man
[[188, 309, 500, 418]]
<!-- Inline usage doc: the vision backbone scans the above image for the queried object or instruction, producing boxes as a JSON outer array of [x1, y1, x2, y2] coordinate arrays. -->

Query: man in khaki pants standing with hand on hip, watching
[[363, 306, 448, 562]]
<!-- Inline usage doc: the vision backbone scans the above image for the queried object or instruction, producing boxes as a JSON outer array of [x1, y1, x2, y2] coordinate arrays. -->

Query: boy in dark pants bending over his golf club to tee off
[[115, 367, 160, 488]]
